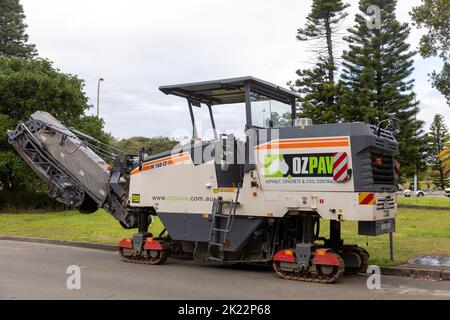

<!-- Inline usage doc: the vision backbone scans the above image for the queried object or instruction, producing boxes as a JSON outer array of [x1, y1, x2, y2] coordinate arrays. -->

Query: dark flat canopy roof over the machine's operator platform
[[159, 77, 299, 105]]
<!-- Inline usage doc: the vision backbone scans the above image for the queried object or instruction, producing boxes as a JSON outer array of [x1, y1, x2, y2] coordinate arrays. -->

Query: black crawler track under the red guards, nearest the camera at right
[[273, 253, 345, 283]]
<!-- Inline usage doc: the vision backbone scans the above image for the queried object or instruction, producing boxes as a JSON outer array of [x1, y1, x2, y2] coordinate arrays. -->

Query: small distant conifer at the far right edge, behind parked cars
[[429, 114, 448, 189]]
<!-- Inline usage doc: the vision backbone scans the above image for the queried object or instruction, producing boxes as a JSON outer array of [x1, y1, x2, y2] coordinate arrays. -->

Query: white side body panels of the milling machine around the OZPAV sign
[[129, 137, 397, 221]]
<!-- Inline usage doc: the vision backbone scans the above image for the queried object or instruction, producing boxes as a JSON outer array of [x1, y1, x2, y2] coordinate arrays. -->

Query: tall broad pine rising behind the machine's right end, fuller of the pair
[[339, 0, 427, 174]]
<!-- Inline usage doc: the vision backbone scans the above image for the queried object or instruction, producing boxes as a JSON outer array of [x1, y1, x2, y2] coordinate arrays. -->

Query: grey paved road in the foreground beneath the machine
[[0, 241, 450, 299]]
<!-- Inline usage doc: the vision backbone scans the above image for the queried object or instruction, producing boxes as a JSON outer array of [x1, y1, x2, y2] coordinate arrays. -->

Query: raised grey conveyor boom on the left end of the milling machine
[[8, 111, 110, 213]]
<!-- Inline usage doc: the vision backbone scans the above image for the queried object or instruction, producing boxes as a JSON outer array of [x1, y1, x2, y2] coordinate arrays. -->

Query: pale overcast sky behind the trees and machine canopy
[[21, 0, 450, 138]]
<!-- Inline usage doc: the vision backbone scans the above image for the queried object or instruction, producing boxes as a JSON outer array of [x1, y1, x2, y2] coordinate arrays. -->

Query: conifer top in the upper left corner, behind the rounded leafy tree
[[0, 0, 37, 58]]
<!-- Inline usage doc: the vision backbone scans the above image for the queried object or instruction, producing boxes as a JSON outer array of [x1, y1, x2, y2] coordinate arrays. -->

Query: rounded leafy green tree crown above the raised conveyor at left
[[0, 56, 90, 125]]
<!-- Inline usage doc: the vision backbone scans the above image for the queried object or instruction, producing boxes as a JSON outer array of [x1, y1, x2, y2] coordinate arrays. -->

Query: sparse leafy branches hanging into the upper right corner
[[410, 0, 450, 105]]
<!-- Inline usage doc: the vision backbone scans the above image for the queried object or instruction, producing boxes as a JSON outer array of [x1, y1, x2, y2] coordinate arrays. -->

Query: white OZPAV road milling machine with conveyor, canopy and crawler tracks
[[8, 77, 398, 283]]
